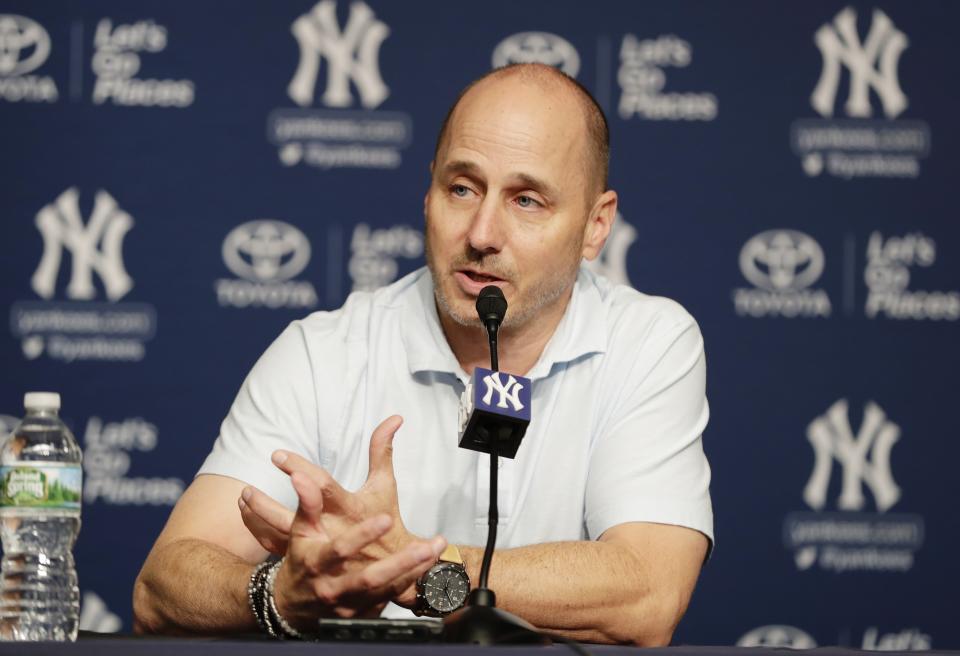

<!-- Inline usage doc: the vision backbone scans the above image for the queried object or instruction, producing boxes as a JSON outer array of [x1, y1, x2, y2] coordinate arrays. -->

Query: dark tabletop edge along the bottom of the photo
[[0, 635, 960, 656]]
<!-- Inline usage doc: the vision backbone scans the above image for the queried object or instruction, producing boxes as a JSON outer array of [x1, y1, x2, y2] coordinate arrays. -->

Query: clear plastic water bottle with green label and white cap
[[0, 392, 82, 641]]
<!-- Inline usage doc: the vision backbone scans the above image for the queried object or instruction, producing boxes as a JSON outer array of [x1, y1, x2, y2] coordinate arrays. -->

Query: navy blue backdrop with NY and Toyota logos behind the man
[[0, 0, 960, 649]]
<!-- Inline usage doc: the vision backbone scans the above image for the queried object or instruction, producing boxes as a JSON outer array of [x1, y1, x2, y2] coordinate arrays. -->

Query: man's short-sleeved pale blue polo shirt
[[199, 268, 713, 548]]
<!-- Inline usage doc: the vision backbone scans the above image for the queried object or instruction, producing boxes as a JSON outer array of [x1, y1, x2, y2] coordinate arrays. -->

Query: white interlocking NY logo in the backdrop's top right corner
[[810, 7, 908, 118]]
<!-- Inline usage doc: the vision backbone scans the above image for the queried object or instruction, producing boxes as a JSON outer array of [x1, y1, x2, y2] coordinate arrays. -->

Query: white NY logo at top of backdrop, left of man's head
[[287, 0, 390, 109]]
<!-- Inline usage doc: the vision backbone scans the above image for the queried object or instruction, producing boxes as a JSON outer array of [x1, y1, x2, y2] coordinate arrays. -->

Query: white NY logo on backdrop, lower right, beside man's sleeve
[[803, 399, 900, 512]]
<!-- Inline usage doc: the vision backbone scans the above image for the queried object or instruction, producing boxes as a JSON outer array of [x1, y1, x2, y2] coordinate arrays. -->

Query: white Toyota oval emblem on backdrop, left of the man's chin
[[223, 219, 310, 283]]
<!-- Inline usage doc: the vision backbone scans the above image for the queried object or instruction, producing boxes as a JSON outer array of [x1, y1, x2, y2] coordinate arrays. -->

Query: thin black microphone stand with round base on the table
[[442, 316, 551, 646]]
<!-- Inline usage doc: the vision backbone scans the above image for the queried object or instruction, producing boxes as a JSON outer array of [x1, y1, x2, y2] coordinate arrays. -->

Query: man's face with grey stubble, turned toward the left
[[424, 77, 595, 328]]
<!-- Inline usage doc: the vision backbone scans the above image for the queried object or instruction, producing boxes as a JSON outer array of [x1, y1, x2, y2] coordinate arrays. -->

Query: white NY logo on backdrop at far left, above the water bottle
[[31, 187, 133, 301]]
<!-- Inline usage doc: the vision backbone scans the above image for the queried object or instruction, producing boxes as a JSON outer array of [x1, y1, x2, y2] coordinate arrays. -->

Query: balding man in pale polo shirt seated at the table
[[134, 64, 712, 645]]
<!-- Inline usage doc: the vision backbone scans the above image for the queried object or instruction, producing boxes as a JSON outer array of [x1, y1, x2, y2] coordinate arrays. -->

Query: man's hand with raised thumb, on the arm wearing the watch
[[239, 416, 444, 614]]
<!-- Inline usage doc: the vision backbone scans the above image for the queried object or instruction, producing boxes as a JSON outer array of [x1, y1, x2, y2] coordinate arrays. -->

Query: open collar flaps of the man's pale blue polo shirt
[[400, 267, 607, 379]]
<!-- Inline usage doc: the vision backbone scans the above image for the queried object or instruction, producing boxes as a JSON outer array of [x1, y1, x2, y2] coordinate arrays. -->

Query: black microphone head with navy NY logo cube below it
[[459, 285, 531, 458]]
